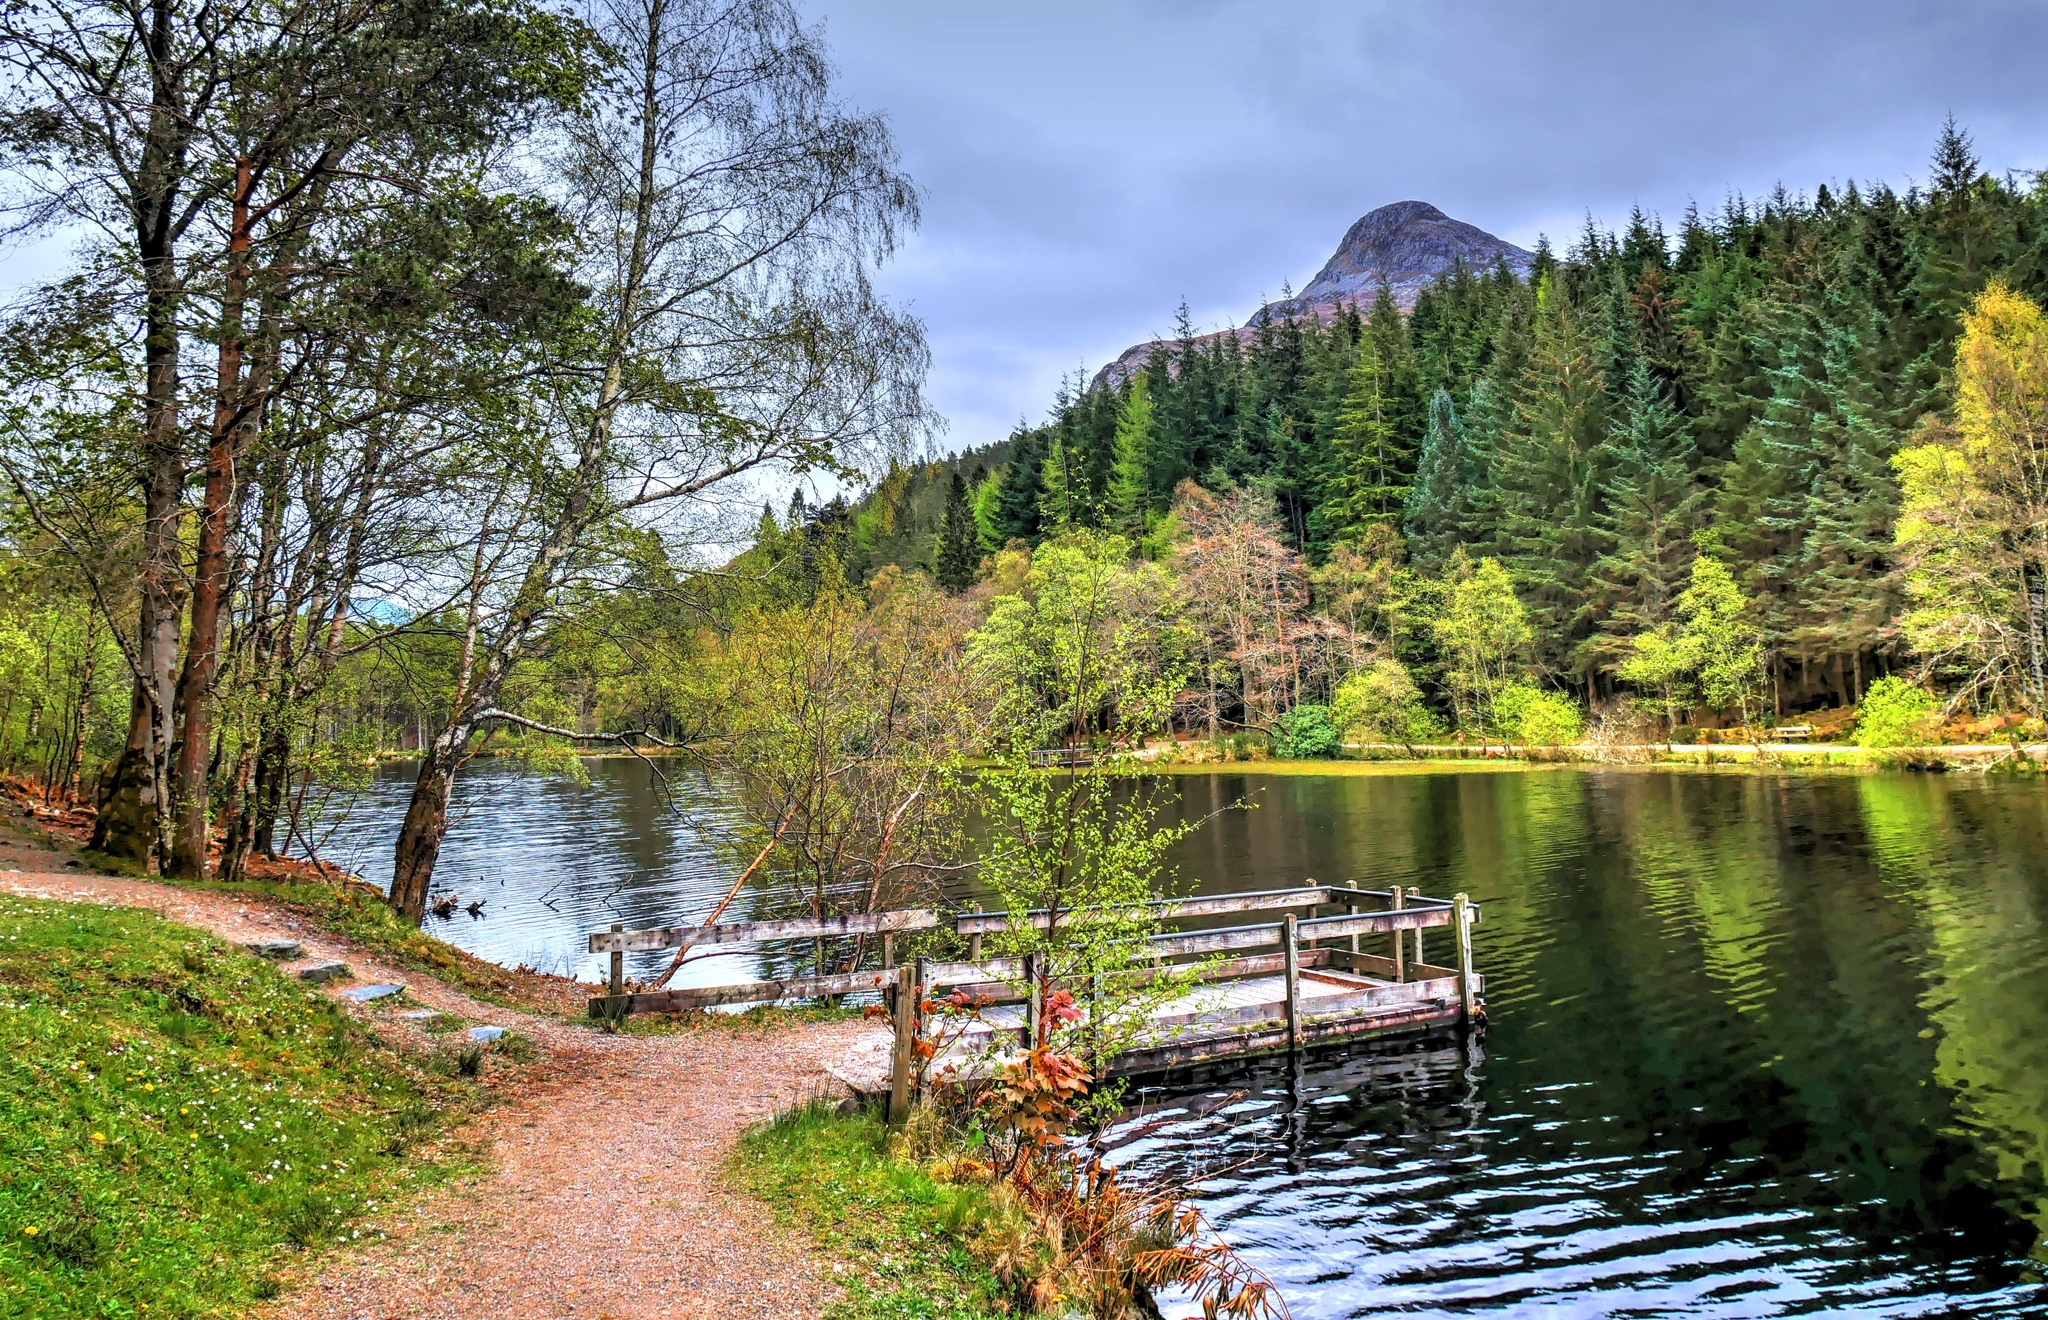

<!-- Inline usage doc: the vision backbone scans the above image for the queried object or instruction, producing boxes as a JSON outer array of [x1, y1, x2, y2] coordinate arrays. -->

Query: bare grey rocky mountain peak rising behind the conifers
[[1096, 201, 1534, 385]]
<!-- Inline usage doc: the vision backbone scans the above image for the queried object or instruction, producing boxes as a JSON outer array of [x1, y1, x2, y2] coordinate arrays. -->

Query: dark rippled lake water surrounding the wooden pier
[[328, 761, 2048, 1320]]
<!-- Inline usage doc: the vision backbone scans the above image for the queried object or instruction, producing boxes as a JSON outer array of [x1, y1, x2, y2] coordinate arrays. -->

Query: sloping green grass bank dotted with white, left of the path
[[0, 896, 477, 1320]]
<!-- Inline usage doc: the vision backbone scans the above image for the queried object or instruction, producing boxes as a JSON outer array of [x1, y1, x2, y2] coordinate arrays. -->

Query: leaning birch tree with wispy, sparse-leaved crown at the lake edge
[[391, 0, 928, 921]]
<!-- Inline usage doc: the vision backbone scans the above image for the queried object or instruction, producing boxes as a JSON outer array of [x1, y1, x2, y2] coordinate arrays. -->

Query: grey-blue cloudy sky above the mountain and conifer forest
[[801, 0, 2048, 458]]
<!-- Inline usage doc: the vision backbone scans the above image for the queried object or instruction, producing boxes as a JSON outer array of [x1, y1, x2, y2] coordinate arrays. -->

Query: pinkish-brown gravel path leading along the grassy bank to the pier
[[0, 841, 858, 1320]]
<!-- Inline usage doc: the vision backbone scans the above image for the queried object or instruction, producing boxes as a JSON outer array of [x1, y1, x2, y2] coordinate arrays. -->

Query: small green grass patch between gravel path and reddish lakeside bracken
[[731, 1105, 1010, 1320]]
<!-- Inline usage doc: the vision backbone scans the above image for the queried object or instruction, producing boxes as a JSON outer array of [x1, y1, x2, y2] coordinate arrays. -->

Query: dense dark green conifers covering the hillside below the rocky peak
[[843, 125, 2048, 710]]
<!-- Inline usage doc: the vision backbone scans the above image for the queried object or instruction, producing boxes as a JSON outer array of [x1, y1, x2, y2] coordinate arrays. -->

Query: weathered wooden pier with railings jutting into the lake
[[590, 884, 1485, 1111]]
